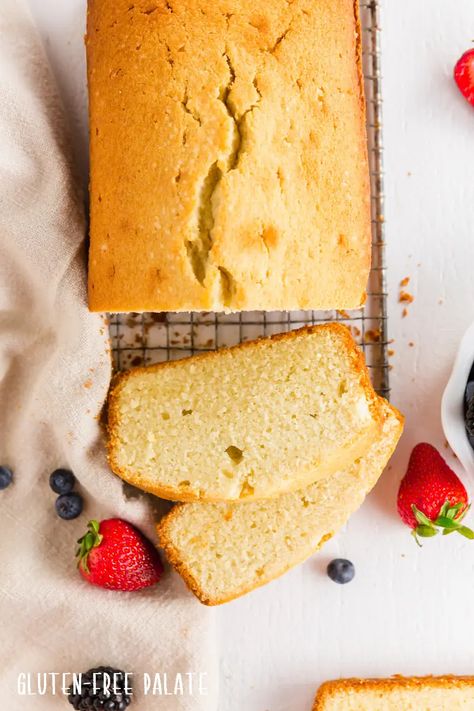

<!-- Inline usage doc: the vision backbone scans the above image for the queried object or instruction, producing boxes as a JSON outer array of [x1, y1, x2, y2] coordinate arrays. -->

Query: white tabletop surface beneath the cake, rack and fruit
[[26, 0, 474, 711]]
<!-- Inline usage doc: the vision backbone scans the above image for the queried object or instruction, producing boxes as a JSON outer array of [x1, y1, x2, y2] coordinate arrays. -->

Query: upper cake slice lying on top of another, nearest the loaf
[[109, 324, 382, 501]]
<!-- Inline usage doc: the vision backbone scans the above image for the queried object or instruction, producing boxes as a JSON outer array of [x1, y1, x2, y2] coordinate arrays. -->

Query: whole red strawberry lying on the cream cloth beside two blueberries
[[76, 518, 163, 590]]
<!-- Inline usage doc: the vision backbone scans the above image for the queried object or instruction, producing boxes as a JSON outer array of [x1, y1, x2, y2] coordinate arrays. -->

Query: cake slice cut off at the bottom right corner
[[313, 676, 474, 711]]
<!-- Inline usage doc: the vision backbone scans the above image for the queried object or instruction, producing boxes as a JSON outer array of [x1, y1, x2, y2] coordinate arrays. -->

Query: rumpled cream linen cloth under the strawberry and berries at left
[[0, 0, 217, 711]]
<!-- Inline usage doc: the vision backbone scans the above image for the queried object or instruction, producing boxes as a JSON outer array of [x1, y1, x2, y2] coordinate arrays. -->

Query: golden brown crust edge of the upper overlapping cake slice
[[107, 323, 384, 503]]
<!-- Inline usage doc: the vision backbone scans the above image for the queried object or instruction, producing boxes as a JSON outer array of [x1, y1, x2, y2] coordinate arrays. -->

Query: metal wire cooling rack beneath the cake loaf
[[110, 0, 389, 396]]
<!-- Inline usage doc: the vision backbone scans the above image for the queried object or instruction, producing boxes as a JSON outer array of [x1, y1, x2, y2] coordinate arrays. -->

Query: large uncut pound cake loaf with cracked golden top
[[86, 0, 371, 312]]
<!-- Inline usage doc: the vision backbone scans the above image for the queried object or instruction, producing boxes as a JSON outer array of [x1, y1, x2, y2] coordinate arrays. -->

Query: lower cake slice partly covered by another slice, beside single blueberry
[[158, 401, 403, 605]]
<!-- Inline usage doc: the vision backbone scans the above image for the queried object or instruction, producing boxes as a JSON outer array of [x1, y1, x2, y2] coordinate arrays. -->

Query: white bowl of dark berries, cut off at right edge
[[441, 323, 474, 476]]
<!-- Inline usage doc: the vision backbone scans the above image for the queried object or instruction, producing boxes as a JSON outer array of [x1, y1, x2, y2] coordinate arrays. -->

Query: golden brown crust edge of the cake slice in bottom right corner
[[313, 674, 474, 711]]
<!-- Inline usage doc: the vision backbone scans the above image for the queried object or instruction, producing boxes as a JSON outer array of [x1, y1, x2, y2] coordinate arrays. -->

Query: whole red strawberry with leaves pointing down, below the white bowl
[[398, 442, 474, 542]]
